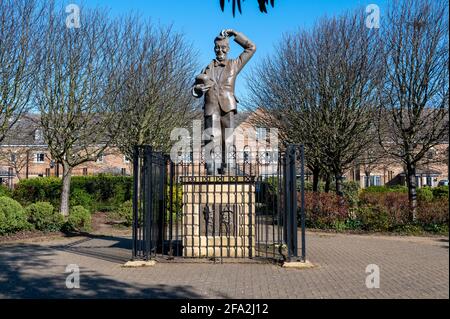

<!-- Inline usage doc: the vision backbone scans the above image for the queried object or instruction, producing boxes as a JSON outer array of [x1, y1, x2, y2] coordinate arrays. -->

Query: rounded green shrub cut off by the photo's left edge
[[0, 196, 32, 235]]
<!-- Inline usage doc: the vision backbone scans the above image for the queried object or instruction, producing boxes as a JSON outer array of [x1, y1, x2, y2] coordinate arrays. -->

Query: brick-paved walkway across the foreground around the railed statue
[[0, 233, 449, 298]]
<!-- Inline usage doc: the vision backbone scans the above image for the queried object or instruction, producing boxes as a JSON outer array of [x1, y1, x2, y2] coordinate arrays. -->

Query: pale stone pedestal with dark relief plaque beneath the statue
[[183, 177, 256, 258]]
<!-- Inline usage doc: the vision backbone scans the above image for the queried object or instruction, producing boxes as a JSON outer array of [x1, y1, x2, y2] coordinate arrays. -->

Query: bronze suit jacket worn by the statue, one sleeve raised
[[192, 33, 256, 116]]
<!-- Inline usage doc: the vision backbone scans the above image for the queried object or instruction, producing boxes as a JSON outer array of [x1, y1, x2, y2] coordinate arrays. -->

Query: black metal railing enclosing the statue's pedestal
[[133, 145, 306, 260]]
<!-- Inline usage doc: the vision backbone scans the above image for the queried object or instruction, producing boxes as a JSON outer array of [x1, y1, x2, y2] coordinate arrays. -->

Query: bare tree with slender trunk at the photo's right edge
[[378, 0, 449, 220]]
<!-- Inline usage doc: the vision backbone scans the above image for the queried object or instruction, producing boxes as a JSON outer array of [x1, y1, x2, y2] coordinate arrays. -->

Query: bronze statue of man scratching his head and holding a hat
[[192, 29, 256, 175]]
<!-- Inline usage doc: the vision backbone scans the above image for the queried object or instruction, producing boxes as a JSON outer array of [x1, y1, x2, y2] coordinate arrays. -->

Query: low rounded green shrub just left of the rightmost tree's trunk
[[356, 206, 391, 231]]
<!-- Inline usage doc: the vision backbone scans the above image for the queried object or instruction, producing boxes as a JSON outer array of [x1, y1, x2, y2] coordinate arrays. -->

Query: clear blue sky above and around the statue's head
[[79, 0, 386, 98]]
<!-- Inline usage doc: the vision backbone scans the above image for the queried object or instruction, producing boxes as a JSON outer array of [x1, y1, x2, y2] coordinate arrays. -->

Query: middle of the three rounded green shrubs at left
[[25, 202, 64, 231]]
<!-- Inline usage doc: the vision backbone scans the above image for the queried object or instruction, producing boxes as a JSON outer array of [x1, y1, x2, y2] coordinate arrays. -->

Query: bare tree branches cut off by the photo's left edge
[[0, 0, 41, 142]]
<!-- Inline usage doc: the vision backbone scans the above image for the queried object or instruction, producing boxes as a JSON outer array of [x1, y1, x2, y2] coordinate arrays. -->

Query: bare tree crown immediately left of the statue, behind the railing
[[112, 18, 196, 158]]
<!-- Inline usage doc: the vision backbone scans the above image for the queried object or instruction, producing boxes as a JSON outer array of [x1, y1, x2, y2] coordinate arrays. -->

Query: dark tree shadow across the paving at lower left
[[0, 240, 200, 299]]
